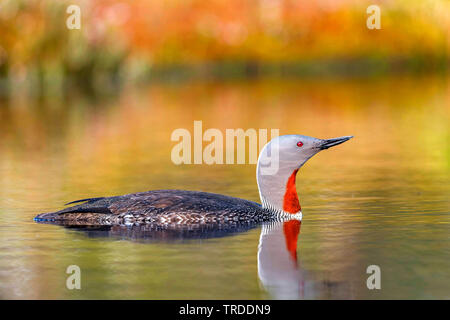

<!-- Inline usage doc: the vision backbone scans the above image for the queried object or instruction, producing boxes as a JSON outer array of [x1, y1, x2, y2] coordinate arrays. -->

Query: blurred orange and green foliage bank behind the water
[[0, 0, 450, 92]]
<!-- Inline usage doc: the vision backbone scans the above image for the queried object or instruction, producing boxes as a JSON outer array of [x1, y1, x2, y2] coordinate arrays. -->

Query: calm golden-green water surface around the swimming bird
[[0, 78, 450, 299]]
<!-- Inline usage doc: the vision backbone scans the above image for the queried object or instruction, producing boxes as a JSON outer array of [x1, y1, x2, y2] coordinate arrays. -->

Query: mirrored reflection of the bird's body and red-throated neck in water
[[40, 220, 350, 299]]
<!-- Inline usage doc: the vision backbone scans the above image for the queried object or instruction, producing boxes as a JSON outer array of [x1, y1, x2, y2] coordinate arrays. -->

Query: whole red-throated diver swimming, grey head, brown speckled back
[[35, 135, 352, 225]]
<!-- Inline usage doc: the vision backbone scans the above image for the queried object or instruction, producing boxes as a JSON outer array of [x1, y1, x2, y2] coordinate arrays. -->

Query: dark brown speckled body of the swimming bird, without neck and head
[[36, 190, 273, 225]]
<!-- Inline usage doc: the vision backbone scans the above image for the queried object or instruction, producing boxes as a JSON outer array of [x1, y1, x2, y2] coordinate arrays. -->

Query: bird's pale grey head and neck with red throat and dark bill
[[256, 135, 353, 217]]
